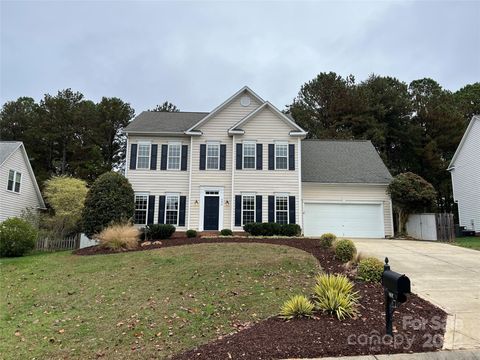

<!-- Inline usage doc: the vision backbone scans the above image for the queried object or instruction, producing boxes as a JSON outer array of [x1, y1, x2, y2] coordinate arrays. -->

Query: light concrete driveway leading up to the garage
[[354, 239, 480, 349]]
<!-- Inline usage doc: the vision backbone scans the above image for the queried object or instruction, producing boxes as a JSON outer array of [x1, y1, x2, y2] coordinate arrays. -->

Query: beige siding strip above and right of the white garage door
[[302, 182, 393, 236]]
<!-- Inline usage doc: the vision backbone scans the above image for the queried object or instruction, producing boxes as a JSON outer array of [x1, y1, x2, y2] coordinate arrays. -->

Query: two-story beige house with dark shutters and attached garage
[[125, 87, 393, 238]]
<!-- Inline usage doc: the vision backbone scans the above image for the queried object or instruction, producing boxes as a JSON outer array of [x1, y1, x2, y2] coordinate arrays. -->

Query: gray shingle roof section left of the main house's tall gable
[[125, 111, 208, 133]]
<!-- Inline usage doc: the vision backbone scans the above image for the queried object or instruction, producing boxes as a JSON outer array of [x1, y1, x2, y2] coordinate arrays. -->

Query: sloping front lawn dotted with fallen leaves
[[0, 244, 319, 359]]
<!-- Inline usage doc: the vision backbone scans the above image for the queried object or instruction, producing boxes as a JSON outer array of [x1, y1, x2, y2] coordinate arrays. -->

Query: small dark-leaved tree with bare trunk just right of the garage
[[388, 172, 436, 234]]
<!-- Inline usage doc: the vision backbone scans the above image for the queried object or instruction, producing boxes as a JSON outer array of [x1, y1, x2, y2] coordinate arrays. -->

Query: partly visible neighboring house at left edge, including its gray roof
[[0, 141, 45, 221]]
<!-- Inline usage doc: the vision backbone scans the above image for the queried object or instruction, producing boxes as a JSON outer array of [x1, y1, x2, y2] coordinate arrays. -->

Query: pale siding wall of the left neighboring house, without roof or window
[[0, 147, 41, 222]]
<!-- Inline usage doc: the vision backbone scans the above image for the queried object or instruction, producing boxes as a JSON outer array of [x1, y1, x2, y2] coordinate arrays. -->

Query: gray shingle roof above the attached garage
[[302, 140, 392, 184]]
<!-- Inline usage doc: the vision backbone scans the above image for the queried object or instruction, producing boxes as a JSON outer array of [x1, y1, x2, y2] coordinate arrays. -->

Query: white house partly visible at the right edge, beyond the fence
[[448, 115, 480, 233]]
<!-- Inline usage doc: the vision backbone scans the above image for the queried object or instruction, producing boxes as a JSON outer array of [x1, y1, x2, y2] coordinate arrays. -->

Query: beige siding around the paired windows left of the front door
[[126, 135, 191, 230]]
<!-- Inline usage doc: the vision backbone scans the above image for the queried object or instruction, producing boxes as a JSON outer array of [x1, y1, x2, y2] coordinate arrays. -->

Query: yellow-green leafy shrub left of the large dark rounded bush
[[43, 176, 88, 236]]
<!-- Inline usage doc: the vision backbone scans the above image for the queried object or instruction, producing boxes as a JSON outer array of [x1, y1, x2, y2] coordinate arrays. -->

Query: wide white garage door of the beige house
[[304, 203, 385, 238]]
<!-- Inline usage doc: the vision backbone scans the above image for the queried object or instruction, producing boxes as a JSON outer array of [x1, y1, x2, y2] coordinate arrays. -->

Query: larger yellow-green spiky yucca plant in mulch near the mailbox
[[313, 274, 359, 320]]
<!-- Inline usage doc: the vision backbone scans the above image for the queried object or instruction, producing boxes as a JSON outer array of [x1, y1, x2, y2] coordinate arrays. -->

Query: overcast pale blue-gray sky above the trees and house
[[0, 0, 480, 114]]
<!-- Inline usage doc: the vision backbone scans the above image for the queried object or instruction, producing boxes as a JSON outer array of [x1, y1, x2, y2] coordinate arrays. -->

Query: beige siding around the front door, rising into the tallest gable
[[189, 94, 260, 229]]
